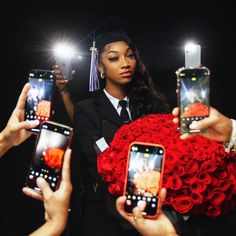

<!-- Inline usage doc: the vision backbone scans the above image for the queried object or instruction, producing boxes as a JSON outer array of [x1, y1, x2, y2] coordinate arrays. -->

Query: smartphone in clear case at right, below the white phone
[[176, 67, 210, 133]]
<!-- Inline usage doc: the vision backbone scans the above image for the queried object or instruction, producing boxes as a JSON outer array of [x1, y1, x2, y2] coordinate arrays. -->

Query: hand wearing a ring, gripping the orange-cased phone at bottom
[[116, 188, 177, 236]]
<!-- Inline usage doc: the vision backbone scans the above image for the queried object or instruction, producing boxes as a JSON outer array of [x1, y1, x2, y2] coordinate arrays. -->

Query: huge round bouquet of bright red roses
[[98, 114, 236, 217]]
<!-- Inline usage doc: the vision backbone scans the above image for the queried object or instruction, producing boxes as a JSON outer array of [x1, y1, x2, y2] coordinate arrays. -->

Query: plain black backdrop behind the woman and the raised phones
[[0, 1, 236, 235]]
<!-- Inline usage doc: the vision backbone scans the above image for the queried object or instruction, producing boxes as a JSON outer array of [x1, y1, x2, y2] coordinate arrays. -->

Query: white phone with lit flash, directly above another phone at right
[[184, 43, 201, 68]]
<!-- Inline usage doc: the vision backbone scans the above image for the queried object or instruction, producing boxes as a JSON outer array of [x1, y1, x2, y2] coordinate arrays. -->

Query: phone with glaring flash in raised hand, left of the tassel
[[55, 56, 73, 80]]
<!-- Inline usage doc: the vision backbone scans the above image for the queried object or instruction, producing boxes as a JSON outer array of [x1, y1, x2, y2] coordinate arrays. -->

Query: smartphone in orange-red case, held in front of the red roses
[[124, 142, 165, 218]]
